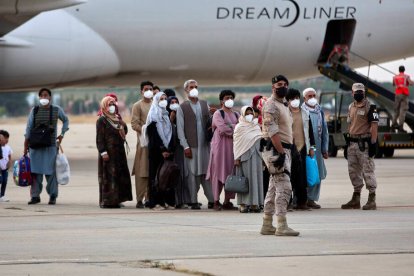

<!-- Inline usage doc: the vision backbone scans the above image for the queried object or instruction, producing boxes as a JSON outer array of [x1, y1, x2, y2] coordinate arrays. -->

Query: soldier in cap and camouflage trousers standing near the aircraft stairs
[[341, 83, 379, 210]]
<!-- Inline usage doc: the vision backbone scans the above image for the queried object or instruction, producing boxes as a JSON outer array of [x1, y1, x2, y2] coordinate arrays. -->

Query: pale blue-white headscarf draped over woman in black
[[145, 91, 172, 148]]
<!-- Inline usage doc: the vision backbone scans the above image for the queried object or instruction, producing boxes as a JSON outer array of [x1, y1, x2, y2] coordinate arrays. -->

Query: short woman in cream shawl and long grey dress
[[233, 106, 263, 213]]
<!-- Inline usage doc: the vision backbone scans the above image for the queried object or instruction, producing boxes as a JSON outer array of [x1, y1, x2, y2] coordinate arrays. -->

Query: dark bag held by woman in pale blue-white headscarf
[[155, 159, 180, 192]]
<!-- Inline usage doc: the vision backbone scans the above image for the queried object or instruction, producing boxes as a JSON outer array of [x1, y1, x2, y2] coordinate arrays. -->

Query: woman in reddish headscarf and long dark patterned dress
[[96, 96, 132, 208]]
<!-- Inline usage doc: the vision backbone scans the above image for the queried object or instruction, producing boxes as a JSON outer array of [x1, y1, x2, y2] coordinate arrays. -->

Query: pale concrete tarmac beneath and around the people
[[0, 124, 414, 276]]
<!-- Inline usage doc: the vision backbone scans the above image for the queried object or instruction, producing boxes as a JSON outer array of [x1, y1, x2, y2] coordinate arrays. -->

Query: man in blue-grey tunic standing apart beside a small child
[[24, 88, 69, 205]]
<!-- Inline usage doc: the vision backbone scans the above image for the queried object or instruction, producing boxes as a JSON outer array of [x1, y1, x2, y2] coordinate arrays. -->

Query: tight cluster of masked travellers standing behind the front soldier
[[97, 76, 329, 218]]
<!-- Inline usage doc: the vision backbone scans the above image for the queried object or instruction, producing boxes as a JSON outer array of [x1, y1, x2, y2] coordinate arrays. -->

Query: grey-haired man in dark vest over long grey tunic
[[177, 80, 214, 210]]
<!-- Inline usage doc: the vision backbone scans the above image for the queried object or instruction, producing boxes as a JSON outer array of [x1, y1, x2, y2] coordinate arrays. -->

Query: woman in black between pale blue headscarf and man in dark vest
[[167, 96, 191, 209]]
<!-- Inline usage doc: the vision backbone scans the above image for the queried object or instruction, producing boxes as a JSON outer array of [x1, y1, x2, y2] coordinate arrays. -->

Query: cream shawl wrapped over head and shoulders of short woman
[[233, 105, 262, 160]]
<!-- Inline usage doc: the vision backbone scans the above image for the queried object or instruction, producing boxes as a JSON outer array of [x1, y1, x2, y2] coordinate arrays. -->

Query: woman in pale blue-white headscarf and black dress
[[146, 92, 175, 209]]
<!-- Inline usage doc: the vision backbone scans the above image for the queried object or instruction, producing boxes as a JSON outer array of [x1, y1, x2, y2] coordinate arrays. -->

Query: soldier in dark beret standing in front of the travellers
[[260, 75, 299, 236]]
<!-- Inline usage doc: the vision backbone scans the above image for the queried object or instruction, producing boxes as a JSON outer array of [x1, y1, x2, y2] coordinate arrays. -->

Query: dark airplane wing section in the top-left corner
[[0, 0, 87, 37]]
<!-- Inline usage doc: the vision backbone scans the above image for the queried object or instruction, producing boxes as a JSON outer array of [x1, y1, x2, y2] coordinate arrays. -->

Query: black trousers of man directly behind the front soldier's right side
[[290, 146, 308, 205]]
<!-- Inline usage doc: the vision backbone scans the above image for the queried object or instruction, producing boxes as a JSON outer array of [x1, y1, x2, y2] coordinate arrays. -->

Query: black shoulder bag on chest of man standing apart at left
[[29, 105, 54, 149]]
